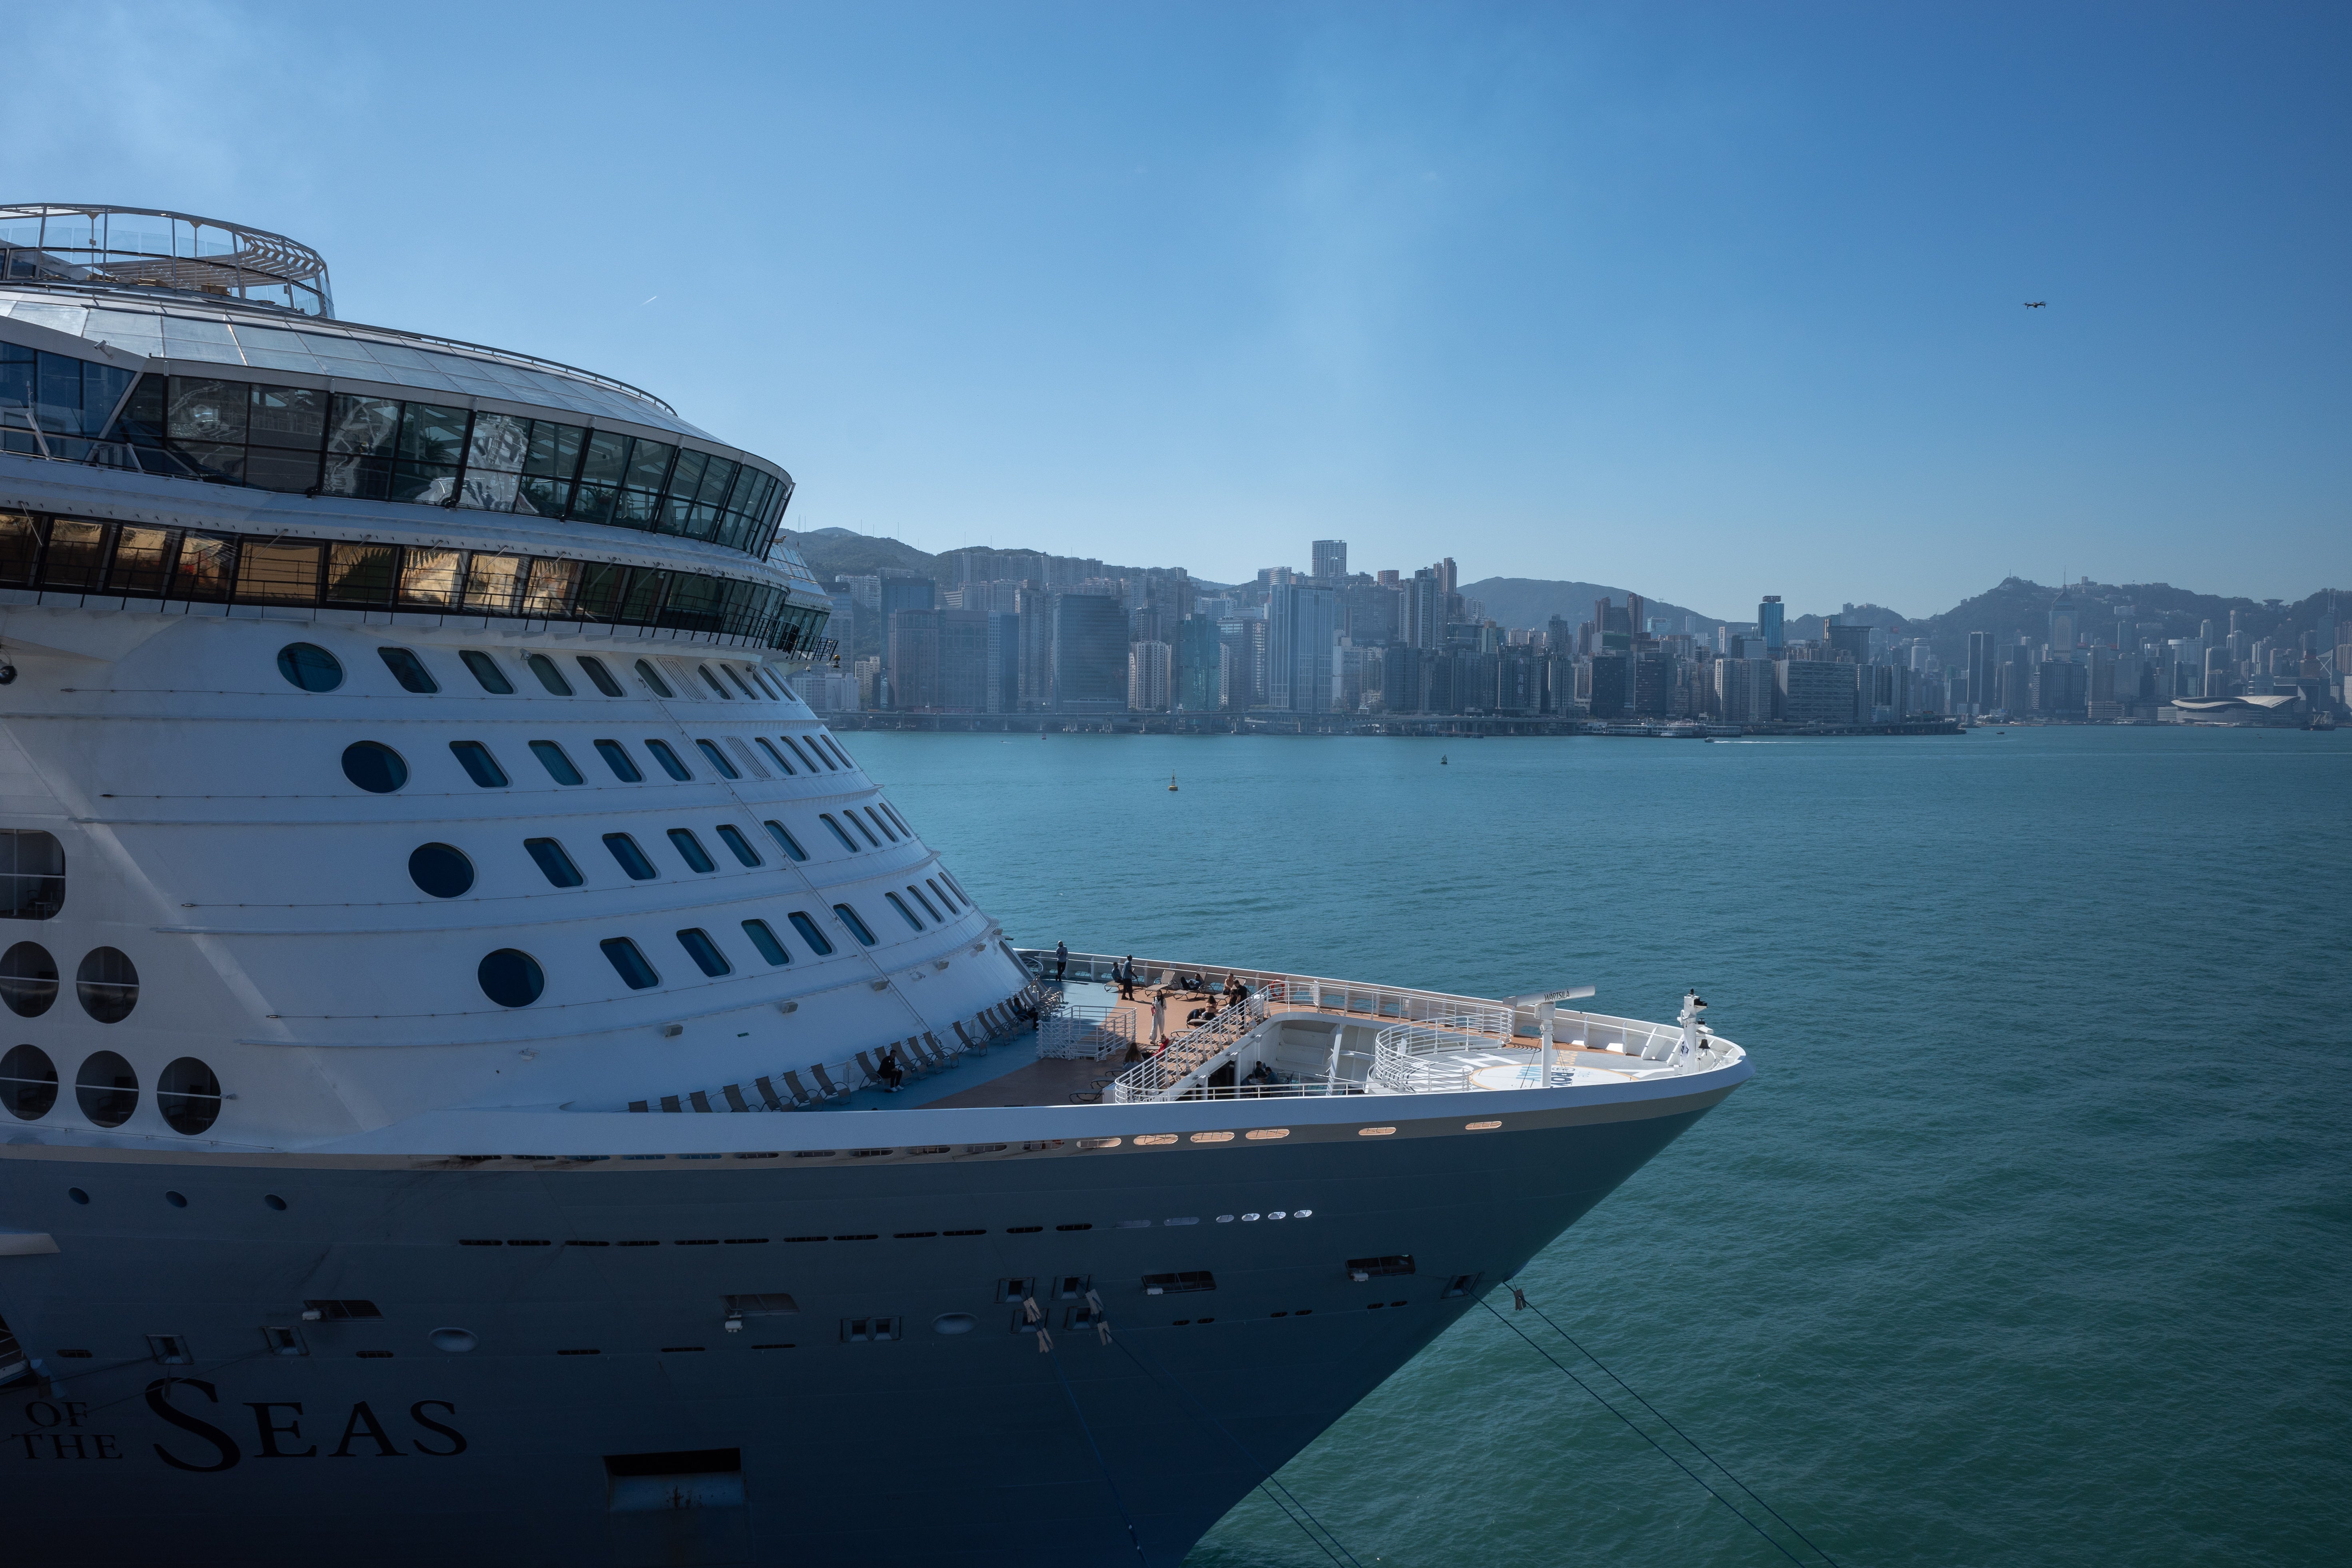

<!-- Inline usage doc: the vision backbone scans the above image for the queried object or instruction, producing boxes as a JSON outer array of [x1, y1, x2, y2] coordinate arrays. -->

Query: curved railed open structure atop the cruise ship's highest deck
[[0, 202, 334, 320]]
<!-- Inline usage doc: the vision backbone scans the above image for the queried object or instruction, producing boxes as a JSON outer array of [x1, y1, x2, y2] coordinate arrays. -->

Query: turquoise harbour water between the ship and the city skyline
[[852, 729, 2352, 1568]]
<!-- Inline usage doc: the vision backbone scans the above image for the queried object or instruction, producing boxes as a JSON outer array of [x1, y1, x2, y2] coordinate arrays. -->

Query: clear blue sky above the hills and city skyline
[[14, 2, 2352, 616]]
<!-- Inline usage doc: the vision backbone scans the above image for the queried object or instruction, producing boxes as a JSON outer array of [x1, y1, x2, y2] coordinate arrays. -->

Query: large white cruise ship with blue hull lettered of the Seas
[[0, 205, 1750, 1568]]
